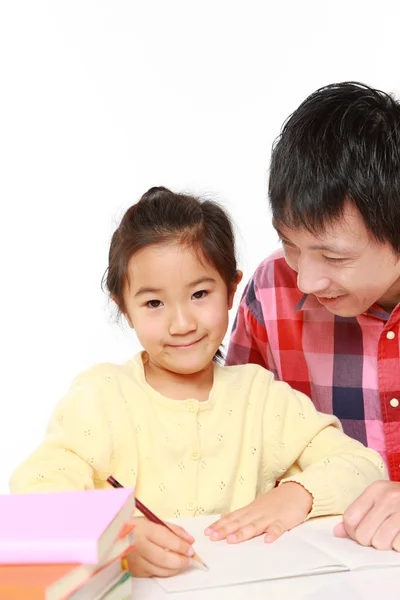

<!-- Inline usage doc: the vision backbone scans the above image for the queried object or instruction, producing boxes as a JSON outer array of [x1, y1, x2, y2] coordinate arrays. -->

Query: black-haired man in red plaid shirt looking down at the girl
[[227, 83, 400, 551]]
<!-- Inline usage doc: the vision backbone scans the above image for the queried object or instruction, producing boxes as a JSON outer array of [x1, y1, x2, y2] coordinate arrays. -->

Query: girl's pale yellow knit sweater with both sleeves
[[11, 354, 387, 518]]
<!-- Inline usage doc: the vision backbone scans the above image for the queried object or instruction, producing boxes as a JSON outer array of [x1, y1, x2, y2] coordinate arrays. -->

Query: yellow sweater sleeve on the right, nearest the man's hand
[[265, 381, 387, 517]]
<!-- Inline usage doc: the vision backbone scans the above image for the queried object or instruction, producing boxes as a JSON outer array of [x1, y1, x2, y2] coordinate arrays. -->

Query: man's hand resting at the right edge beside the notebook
[[334, 481, 400, 552]]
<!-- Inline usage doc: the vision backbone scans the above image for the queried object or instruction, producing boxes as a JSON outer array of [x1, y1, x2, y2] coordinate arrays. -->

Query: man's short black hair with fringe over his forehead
[[269, 82, 400, 253]]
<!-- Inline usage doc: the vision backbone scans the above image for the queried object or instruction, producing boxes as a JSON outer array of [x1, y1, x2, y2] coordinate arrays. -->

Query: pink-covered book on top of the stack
[[0, 488, 135, 564]]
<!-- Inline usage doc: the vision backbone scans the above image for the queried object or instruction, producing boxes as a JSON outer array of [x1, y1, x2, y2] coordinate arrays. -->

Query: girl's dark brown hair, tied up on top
[[103, 187, 237, 357]]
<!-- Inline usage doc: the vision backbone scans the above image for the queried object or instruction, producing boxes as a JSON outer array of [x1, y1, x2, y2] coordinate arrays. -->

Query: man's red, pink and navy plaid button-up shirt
[[226, 251, 400, 481]]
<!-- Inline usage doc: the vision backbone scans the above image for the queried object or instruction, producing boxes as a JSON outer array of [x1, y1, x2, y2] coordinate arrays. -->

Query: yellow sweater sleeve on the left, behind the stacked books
[[10, 371, 113, 493]]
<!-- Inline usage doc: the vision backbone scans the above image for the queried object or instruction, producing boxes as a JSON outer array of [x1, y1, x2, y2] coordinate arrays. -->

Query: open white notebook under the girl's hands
[[157, 516, 400, 592]]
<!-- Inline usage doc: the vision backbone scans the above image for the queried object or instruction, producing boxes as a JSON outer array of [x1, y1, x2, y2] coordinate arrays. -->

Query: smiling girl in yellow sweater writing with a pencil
[[11, 188, 386, 576]]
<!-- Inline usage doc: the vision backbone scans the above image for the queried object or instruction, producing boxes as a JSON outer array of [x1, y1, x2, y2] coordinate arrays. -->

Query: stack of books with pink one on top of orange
[[0, 488, 135, 600]]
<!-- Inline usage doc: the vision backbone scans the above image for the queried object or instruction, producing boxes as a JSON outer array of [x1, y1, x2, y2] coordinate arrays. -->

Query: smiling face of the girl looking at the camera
[[124, 243, 241, 374]]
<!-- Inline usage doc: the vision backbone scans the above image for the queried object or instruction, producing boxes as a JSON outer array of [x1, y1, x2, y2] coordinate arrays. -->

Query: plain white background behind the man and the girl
[[0, 0, 400, 493]]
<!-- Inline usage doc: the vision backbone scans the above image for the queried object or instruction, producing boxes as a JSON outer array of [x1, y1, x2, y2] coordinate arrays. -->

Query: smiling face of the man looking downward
[[274, 202, 400, 317]]
